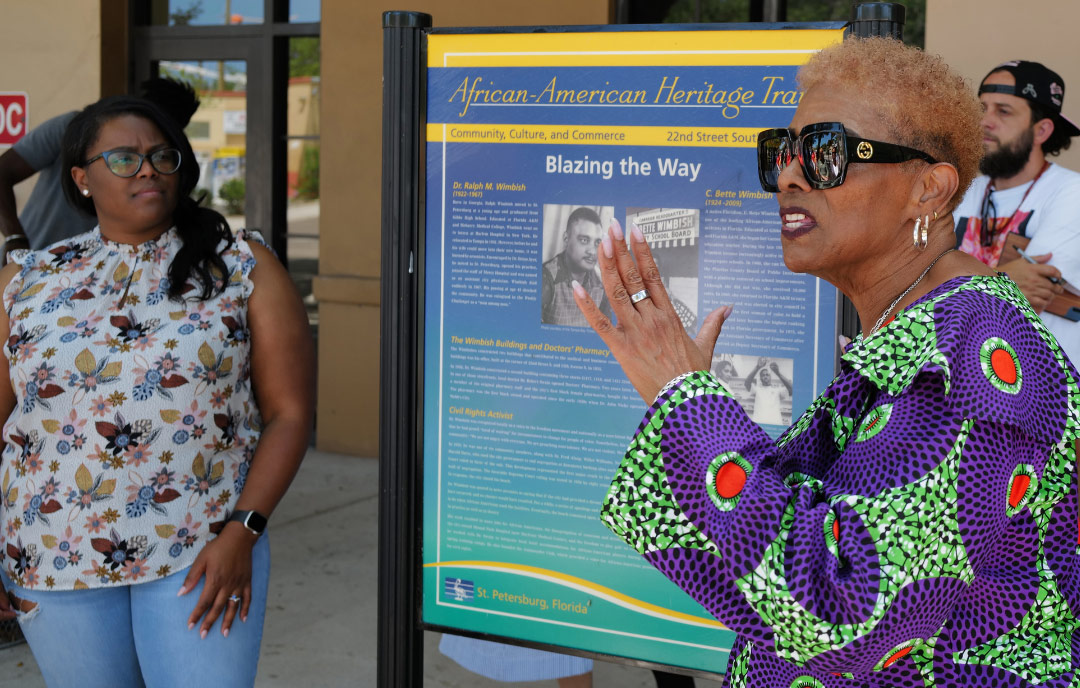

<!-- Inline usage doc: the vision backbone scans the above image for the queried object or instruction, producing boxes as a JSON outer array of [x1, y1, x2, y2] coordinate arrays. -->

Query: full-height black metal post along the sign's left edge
[[378, 12, 431, 688]]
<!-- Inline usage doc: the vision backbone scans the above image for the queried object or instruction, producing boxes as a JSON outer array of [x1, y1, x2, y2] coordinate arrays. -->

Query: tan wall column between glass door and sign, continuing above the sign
[[314, 0, 610, 457]]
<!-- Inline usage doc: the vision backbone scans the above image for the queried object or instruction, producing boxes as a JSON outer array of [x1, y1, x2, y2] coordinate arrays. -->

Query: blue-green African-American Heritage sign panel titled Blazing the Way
[[423, 25, 842, 673]]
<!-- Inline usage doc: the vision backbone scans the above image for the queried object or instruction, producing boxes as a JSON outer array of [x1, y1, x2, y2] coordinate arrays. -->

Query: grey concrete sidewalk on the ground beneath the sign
[[0, 449, 717, 688]]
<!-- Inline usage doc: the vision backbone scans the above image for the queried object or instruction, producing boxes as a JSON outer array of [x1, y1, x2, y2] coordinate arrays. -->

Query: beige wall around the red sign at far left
[[0, 0, 102, 207]]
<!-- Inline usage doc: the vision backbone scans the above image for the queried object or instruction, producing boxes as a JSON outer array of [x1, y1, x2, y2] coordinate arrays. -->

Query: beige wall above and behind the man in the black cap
[[927, 0, 1080, 170]]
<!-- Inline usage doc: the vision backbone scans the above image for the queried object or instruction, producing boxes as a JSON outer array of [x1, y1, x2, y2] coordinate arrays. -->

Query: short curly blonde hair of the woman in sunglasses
[[798, 38, 983, 211]]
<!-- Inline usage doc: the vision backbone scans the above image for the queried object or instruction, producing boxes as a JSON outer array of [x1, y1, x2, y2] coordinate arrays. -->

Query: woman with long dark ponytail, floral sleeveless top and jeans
[[0, 97, 313, 687]]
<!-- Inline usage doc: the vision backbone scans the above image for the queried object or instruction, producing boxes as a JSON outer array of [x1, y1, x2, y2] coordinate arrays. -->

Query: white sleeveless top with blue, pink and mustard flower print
[[0, 228, 261, 590]]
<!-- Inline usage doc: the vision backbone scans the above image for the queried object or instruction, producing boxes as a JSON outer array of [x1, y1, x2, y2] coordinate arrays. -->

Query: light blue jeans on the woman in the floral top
[[3, 535, 270, 688]]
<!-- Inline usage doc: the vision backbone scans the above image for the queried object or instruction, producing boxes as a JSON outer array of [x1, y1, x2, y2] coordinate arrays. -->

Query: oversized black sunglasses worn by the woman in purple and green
[[757, 122, 937, 193]]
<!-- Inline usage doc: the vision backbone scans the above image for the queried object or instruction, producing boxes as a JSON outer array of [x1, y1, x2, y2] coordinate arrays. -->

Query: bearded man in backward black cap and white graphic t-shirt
[[954, 60, 1080, 363]]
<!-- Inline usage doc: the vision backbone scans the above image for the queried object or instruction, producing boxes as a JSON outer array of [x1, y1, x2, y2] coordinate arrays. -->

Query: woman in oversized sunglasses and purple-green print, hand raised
[[577, 39, 1080, 688]]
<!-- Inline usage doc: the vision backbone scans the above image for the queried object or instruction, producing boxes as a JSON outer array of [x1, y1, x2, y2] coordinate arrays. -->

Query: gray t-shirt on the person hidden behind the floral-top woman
[[14, 111, 97, 251]]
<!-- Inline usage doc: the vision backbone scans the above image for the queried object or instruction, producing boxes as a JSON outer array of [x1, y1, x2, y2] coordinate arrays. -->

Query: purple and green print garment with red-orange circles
[[603, 276, 1080, 688]]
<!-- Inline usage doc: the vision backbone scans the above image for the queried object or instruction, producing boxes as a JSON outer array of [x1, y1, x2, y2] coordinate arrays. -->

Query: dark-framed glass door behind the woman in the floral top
[[130, 0, 321, 334]]
